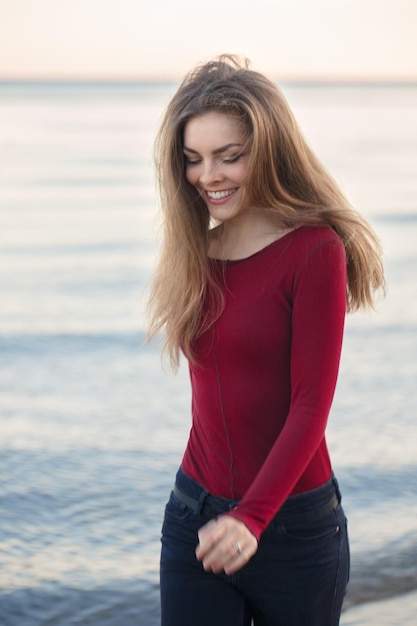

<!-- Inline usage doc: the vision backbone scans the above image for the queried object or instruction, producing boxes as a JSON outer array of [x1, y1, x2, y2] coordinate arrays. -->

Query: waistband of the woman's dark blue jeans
[[173, 467, 342, 525]]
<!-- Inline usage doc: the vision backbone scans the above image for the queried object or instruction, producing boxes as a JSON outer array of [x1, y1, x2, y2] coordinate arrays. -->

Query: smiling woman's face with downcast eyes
[[184, 111, 250, 222]]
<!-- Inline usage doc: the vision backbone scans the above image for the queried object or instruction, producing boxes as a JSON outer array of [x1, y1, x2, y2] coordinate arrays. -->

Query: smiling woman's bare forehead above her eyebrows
[[184, 111, 245, 147]]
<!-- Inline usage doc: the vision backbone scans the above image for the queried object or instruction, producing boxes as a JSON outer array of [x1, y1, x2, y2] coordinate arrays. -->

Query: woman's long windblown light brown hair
[[148, 55, 384, 369]]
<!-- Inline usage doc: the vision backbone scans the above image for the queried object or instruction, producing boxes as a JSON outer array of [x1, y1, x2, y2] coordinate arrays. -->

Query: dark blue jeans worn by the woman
[[161, 469, 349, 626]]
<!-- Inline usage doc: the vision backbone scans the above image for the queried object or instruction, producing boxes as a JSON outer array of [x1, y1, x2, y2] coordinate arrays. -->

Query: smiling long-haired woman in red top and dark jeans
[[149, 55, 384, 626]]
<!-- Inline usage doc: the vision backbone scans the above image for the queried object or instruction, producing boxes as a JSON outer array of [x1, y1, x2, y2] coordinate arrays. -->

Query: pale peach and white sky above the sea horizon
[[0, 0, 417, 81]]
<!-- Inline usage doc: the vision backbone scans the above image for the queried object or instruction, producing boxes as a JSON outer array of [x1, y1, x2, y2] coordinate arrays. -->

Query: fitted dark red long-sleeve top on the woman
[[182, 227, 346, 539]]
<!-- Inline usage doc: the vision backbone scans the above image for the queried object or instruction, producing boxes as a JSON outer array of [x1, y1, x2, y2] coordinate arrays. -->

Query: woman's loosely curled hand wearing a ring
[[196, 515, 258, 575]]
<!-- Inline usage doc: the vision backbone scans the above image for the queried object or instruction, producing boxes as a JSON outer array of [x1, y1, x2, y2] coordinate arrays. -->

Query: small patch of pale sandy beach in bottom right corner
[[340, 591, 417, 626]]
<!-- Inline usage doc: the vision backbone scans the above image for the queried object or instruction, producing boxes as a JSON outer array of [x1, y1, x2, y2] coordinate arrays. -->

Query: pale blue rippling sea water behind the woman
[[0, 83, 417, 626]]
